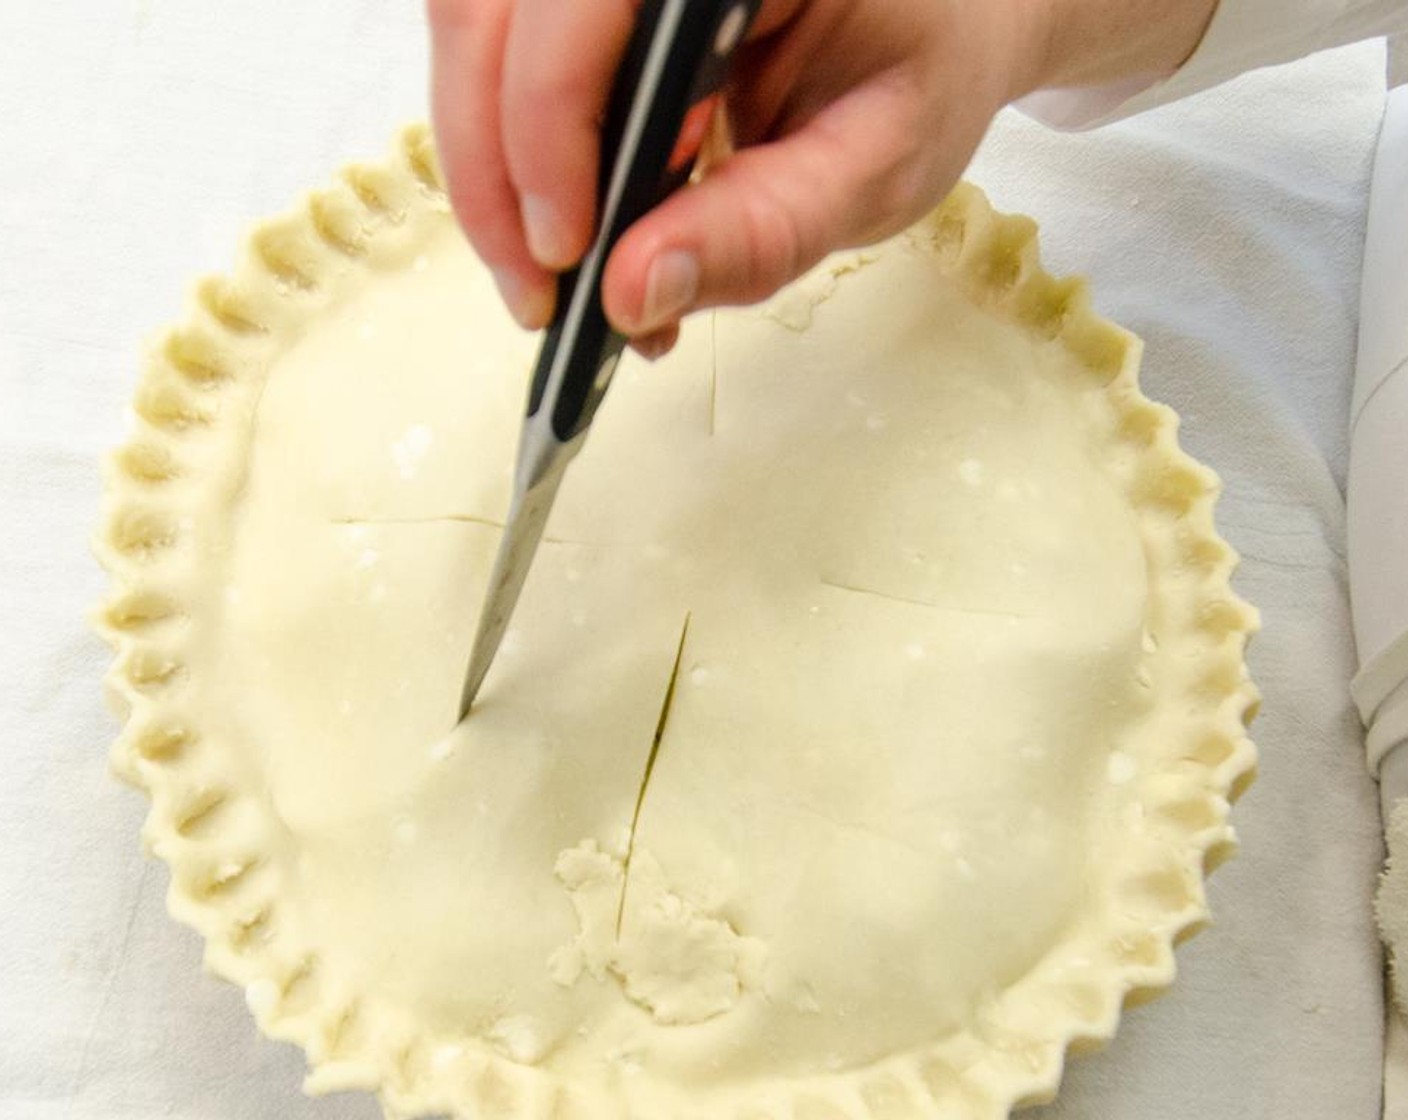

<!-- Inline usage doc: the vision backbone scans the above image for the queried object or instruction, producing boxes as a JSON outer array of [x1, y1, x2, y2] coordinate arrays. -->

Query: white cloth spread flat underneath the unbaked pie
[[0, 0, 1384, 1120]]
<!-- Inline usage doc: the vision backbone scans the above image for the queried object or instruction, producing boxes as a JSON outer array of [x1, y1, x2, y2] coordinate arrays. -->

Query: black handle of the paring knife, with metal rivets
[[528, 0, 760, 442]]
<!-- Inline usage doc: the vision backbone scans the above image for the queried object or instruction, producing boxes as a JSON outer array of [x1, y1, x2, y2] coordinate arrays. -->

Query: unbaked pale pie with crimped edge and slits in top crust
[[99, 128, 1256, 1120]]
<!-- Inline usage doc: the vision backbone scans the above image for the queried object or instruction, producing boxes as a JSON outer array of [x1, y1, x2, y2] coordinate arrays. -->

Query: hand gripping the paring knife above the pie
[[428, 0, 1215, 356]]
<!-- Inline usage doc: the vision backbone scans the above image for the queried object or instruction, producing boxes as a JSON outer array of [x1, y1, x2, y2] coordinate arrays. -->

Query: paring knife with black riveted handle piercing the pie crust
[[459, 0, 760, 720]]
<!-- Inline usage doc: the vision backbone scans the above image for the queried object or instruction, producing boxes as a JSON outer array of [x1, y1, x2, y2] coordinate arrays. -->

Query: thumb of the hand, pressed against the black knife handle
[[604, 81, 934, 335]]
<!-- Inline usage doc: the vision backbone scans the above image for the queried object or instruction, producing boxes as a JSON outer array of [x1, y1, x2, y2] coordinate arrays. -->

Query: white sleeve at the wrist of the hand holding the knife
[[1018, 0, 1408, 128]]
